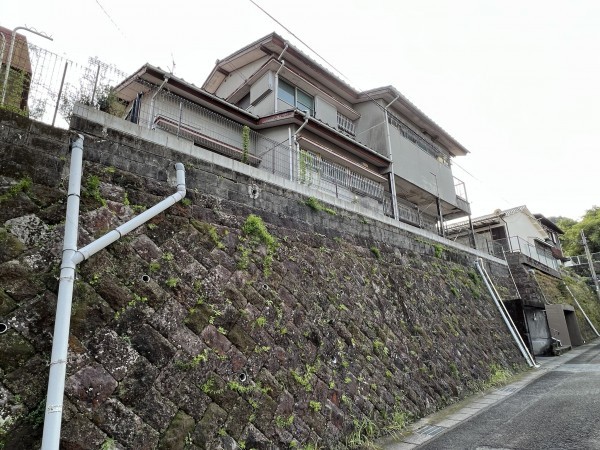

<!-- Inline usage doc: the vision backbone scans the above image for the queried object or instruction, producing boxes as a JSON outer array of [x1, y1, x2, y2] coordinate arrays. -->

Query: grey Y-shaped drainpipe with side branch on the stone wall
[[42, 135, 186, 450]]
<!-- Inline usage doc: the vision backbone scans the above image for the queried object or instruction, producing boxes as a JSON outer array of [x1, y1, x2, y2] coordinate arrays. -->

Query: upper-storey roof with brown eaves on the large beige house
[[202, 33, 469, 156]]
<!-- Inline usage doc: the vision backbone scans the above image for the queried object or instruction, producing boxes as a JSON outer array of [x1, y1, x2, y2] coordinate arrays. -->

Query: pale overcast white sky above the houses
[[0, 0, 600, 220]]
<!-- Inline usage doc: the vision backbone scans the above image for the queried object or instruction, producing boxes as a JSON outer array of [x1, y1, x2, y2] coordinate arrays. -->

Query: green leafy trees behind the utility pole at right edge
[[556, 206, 600, 256]]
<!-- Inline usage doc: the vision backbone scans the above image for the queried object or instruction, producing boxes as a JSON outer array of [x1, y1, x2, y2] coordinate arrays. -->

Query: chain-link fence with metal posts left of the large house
[[0, 33, 125, 128]]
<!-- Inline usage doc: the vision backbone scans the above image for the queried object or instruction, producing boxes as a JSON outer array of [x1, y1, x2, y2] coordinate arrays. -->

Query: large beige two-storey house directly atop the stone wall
[[115, 33, 470, 230]]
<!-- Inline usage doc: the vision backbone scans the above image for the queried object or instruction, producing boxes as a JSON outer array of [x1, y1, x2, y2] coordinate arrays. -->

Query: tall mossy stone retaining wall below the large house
[[0, 113, 524, 449]]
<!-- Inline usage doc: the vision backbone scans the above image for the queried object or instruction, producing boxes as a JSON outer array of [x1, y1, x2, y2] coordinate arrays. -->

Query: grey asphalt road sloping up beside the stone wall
[[416, 344, 600, 450]]
